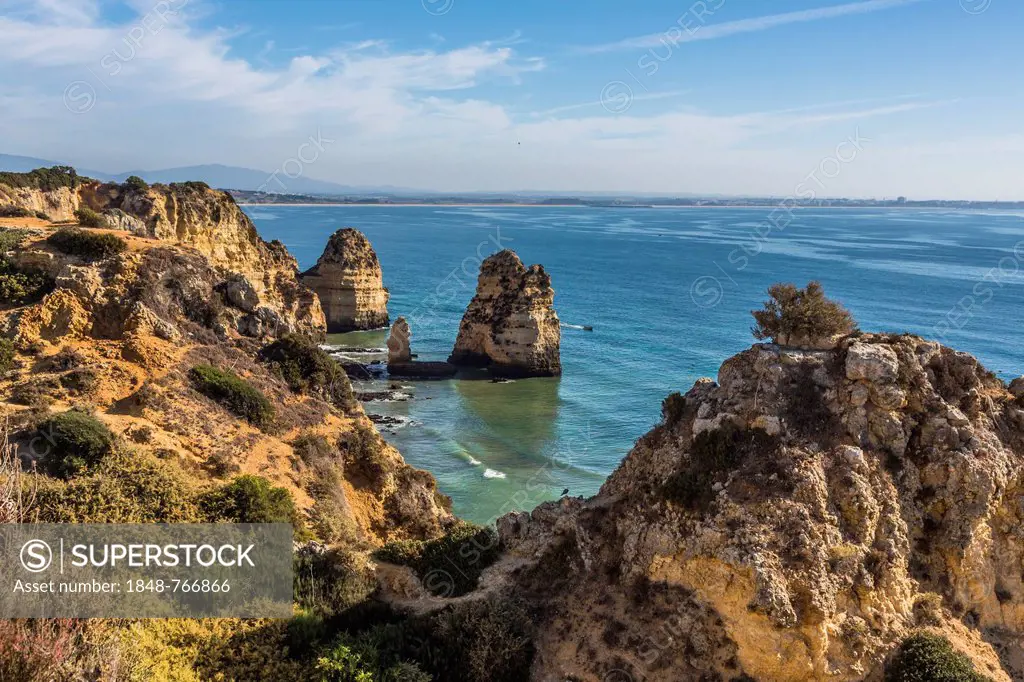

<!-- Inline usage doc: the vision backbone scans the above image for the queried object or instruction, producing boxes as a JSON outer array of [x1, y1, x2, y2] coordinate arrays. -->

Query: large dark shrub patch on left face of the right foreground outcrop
[[663, 422, 778, 511]]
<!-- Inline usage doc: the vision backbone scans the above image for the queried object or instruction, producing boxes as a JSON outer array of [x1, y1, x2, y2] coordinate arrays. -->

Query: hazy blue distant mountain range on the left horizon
[[0, 154, 419, 197]]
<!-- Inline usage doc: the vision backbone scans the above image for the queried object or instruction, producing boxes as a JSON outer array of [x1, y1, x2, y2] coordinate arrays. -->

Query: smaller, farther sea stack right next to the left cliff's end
[[302, 227, 389, 334]]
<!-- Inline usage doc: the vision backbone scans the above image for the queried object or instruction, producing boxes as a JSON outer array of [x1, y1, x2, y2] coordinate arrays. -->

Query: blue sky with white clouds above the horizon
[[0, 0, 1024, 200]]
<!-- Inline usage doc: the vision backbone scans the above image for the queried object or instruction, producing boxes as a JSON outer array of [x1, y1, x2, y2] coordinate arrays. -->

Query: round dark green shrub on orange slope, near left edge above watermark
[[35, 410, 115, 478]]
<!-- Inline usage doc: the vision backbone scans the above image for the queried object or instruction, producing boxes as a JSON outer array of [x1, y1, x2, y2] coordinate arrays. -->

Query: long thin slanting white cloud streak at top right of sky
[[582, 0, 923, 53]]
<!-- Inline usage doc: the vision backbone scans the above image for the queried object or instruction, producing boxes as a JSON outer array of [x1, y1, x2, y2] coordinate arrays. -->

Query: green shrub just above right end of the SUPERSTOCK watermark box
[[200, 475, 301, 524]]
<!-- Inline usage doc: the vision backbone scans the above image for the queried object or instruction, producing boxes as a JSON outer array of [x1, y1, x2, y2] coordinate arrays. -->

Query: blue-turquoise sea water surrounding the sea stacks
[[246, 206, 1024, 522]]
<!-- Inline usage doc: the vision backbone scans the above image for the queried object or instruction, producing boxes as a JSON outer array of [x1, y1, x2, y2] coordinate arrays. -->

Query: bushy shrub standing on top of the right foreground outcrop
[[751, 282, 856, 342]]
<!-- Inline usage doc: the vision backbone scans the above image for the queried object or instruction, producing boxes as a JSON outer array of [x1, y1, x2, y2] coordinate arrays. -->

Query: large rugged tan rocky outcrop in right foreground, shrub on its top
[[498, 335, 1024, 682]]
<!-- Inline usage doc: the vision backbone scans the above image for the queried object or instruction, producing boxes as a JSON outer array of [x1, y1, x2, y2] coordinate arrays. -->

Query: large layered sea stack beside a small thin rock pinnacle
[[449, 249, 562, 377]]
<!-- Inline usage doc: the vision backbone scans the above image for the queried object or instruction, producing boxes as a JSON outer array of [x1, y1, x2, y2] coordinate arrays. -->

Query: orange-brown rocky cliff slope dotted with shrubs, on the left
[[0, 209, 454, 546]]
